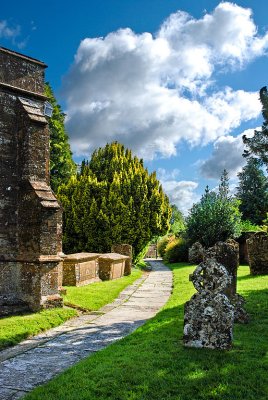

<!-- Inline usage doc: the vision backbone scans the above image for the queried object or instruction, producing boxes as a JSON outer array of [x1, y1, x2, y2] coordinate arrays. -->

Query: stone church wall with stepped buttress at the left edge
[[0, 47, 62, 315]]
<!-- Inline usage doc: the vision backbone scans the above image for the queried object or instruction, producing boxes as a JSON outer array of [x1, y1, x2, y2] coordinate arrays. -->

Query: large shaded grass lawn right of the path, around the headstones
[[25, 263, 268, 400]]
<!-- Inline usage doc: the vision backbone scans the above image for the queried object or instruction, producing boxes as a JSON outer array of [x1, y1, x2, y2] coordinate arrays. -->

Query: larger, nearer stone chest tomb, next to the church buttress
[[62, 253, 99, 286]]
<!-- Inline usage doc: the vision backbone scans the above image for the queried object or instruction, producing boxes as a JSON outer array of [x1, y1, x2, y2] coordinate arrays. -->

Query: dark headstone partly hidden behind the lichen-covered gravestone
[[204, 239, 248, 323]]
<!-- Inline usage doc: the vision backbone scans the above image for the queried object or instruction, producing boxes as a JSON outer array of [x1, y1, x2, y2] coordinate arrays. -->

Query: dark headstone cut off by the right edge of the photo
[[247, 232, 268, 275]]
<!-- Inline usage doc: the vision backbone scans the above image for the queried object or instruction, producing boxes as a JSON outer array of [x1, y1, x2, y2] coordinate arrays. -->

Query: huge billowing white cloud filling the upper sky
[[63, 2, 268, 159]]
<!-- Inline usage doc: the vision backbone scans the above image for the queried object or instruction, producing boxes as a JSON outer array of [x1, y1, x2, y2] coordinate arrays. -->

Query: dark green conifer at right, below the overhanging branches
[[236, 158, 268, 225]]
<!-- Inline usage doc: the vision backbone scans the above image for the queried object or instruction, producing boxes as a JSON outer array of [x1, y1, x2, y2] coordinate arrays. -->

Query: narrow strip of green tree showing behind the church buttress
[[45, 83, 76, 192]]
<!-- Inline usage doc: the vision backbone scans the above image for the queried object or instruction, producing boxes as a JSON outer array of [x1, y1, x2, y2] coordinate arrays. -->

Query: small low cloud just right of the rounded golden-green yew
[[157, 168, 200, 215]]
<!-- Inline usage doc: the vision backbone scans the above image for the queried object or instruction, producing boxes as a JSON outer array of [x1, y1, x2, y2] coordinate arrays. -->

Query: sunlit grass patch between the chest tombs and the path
[[63, 269, 142, 311]]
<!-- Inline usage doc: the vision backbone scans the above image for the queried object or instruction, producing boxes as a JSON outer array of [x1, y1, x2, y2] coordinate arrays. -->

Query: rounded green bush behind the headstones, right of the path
[[186, 171, 240, 247]]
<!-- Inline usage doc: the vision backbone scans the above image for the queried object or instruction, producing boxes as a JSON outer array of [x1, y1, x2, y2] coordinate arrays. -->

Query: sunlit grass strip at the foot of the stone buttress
[[0, 308, 77, 350]]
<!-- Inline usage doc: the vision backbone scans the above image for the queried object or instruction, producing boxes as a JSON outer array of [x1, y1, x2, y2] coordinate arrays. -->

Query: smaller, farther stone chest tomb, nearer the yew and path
[[98, 253, 129, 281]]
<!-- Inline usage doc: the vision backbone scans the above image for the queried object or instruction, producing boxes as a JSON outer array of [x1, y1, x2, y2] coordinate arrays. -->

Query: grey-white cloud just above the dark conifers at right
[[200, 128, 259, 179]]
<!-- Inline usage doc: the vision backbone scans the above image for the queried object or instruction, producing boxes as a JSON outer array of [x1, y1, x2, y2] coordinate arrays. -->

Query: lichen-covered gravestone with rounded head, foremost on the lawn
[[183, 259, 234, 350]]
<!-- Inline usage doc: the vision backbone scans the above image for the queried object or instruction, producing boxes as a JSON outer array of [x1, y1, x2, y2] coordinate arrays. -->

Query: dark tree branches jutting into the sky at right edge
[[243, 86, 268, 170]]
